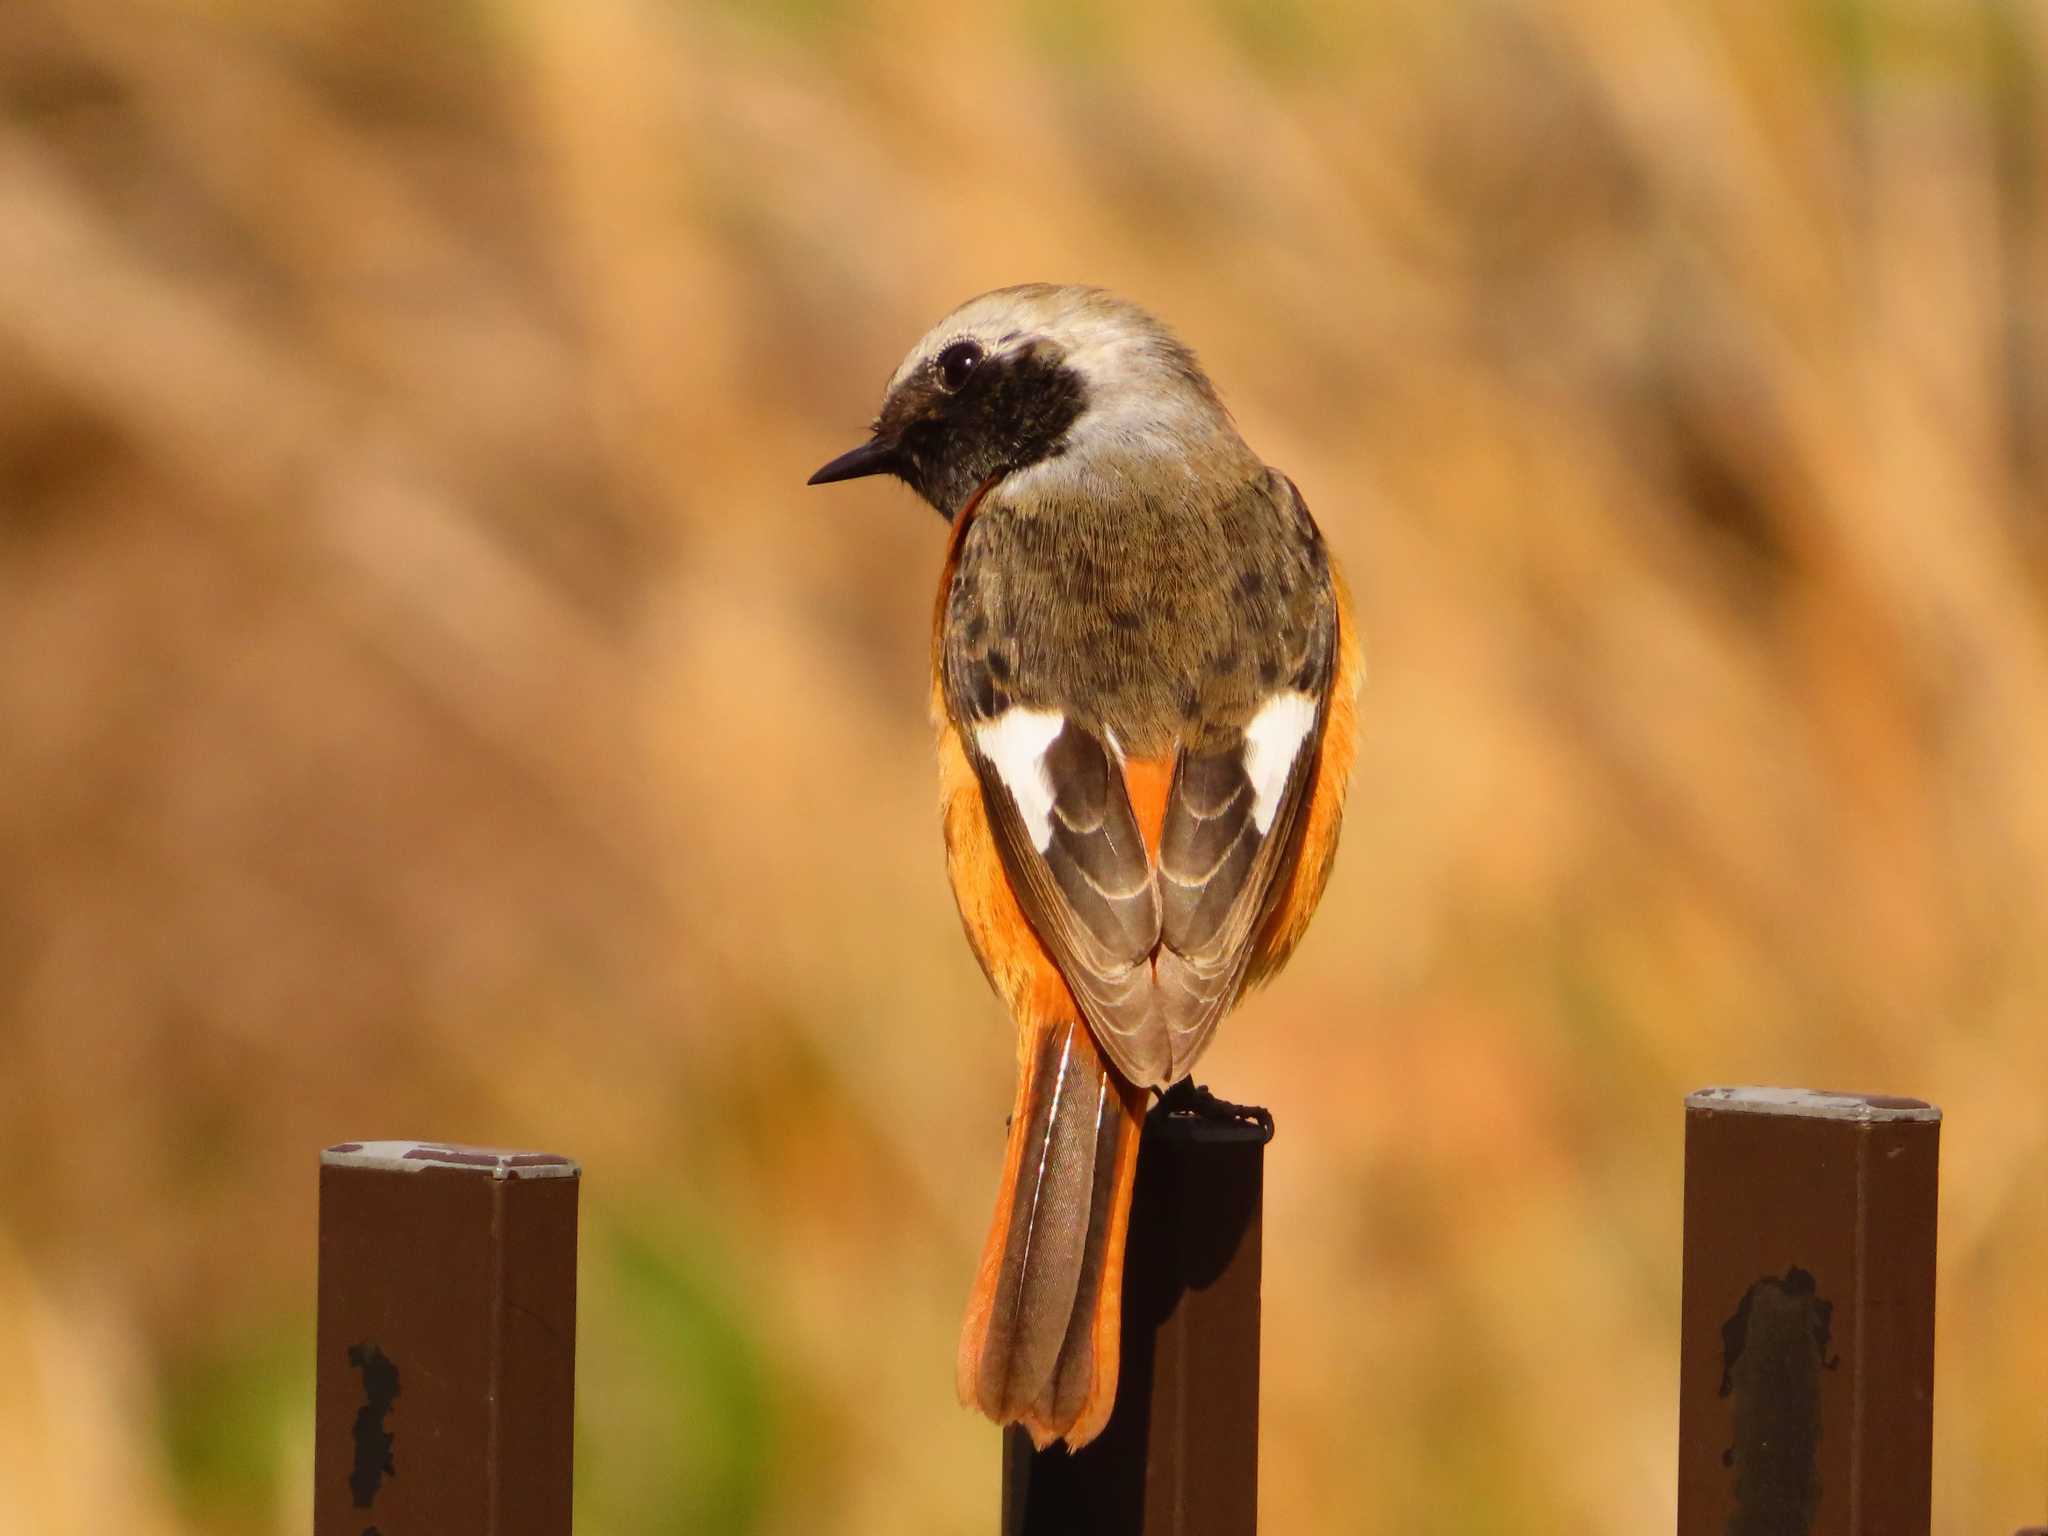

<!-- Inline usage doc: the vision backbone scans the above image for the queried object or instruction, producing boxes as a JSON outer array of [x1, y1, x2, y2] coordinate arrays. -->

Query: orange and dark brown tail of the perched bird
[[961, 1020, 1145, 1450]]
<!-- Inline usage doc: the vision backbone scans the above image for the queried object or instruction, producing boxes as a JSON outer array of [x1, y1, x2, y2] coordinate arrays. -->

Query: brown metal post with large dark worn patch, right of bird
[[1677, 1087, 1942, 1536]]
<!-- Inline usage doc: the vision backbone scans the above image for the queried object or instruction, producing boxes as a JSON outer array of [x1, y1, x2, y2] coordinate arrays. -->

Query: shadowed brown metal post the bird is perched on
[[1001, 1108, 1270, 1536]]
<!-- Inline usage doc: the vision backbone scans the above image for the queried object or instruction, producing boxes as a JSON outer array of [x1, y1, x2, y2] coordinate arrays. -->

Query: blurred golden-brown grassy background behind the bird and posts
[[0, 0, 2048, 1536]]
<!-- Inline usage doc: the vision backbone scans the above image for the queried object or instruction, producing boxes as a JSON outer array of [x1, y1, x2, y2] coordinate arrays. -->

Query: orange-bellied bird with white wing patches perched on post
[[809, 283, 1362, 1450]]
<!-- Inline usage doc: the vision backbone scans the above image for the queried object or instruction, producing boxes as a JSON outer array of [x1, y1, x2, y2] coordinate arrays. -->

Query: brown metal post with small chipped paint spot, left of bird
[[313, 1141, 580, 1536]]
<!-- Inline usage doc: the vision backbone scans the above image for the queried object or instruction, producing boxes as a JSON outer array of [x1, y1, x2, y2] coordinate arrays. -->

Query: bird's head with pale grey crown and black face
[[811, 283, 1235, 520]]
